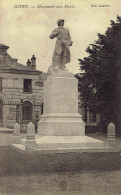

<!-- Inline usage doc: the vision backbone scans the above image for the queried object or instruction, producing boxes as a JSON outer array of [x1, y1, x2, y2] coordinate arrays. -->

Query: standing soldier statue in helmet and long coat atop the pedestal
[[48, 19, 73, 73]]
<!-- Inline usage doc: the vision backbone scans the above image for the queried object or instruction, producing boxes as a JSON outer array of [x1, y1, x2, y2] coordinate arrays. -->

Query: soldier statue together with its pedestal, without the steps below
[[38, 19, 85, 136]]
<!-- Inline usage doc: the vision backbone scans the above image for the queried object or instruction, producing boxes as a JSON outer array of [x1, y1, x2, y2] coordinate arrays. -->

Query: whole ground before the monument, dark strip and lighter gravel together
[[0, 134, 121, 195]]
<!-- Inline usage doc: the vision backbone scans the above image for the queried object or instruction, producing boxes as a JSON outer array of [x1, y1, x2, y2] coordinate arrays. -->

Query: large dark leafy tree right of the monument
[[79, 16, 121, 133]]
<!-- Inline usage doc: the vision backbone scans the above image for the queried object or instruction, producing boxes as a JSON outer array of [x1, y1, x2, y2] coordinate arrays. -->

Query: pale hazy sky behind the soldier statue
[[0, 0, 121, 74]]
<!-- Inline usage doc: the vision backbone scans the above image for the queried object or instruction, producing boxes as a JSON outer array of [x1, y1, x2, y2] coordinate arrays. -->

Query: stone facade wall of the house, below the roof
[[0, 70, 43, 127]]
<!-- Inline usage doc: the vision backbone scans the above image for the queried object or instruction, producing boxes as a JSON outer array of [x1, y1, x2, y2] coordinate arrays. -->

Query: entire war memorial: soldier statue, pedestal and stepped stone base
[[13, 19, 111, 154]]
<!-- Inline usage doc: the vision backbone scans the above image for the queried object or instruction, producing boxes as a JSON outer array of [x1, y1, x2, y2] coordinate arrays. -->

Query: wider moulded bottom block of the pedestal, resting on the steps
[[38, 113, 85, 136]]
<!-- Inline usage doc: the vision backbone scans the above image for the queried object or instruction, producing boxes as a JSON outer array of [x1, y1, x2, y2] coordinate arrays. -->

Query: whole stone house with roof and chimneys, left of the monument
[[0, 44, 46, 132]]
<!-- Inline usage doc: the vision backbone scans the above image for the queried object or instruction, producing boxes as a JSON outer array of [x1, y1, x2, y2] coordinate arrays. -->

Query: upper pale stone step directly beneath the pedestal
[[21, 135, 106, 150]]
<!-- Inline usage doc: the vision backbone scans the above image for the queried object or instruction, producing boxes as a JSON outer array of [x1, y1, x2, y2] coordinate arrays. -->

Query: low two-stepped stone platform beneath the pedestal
[[11, 135, 119, 154]]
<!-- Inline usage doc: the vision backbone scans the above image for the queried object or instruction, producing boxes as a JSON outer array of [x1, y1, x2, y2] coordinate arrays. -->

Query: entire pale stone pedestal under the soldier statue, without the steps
[[38, 71, 85, 136]]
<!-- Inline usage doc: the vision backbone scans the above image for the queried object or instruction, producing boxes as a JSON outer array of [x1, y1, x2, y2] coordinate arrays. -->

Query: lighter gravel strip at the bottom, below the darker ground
[[0, 171, 121, 195]]
